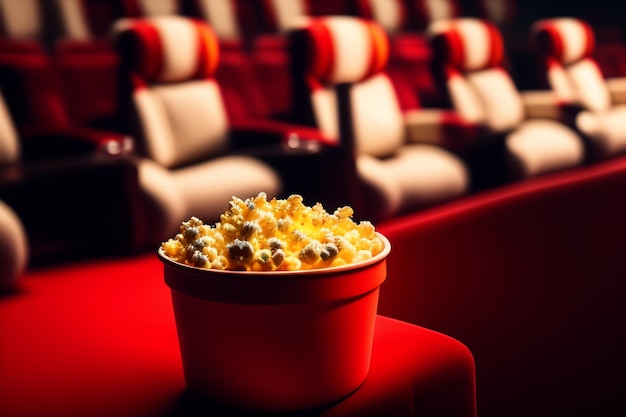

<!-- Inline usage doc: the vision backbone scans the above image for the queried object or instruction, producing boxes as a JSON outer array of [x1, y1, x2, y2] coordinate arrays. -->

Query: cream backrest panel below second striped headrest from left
[[351, 74, 406, 157]]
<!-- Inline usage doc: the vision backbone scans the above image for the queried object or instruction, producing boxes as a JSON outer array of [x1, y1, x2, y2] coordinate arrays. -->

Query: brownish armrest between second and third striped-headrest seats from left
[[404, 109, 485, 151]]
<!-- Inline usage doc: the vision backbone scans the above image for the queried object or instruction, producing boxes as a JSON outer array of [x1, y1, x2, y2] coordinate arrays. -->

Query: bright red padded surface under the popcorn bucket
[[0, 253, 476, 417]]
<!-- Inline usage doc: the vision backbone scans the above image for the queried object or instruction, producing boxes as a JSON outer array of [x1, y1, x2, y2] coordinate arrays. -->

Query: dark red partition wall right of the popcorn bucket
[[378, 154, 626, 417]]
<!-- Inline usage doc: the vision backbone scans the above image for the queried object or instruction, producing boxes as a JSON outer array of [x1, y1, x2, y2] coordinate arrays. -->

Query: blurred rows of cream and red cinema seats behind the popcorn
[[0, 0, 623, 272]]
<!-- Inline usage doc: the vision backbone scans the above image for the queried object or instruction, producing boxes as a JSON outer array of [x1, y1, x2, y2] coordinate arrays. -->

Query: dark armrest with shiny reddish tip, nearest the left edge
[[20, 127, 135, 162]]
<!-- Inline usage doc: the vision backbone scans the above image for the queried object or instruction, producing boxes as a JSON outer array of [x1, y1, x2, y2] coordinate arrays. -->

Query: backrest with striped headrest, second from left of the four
[[292, 16, 405, 157]]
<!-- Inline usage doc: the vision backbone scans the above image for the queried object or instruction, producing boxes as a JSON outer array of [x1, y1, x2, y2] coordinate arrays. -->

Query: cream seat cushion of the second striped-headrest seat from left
[[385, 144, 470, 211]]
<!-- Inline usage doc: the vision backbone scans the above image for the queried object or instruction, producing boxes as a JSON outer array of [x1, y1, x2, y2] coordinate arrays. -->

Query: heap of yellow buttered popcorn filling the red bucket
[[161, 193, 384, 271]]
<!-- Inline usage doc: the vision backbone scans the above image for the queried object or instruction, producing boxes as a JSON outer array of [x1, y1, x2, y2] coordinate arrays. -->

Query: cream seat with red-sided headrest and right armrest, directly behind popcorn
[[115, 16, 336, 249]]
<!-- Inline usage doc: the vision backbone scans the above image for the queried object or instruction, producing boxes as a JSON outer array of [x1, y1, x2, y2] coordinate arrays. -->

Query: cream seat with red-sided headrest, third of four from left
[[428, 18, 585, 188]]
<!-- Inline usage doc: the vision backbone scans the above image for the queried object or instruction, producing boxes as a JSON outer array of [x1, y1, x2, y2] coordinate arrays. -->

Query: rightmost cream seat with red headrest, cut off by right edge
[[532, 17, 626, 160]]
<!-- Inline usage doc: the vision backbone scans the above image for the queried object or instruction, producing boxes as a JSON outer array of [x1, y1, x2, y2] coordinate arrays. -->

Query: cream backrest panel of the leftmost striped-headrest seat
[[134, 80, 228, 168]]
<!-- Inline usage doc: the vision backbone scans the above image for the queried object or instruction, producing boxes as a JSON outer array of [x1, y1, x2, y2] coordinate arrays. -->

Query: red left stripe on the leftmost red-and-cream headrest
[[133, 20, 163, 80]]
